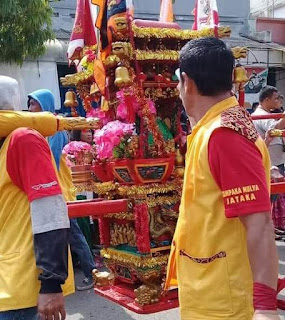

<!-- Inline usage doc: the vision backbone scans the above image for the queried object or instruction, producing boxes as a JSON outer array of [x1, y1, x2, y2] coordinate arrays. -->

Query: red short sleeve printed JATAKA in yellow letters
[[208, 128, 271, 218]]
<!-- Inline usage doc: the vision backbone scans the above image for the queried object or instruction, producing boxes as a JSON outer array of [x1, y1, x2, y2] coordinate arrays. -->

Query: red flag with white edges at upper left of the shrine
[[67, 0, 97, 60]]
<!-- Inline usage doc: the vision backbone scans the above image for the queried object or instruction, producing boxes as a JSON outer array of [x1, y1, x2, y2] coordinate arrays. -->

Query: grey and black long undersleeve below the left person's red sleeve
[[30, 195, 70, 293]]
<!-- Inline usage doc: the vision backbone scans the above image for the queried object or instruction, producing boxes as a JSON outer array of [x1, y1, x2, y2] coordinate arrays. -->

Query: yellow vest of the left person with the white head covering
[[0, 133, 74, 311]]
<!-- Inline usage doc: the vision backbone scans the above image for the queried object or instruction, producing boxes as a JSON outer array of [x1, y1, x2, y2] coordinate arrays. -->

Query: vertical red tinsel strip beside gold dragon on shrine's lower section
[[134, 203, 150, 253]]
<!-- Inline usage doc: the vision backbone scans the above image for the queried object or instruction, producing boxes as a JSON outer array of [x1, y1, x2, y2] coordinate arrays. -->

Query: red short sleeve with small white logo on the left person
[[6, 128, 62, 202]]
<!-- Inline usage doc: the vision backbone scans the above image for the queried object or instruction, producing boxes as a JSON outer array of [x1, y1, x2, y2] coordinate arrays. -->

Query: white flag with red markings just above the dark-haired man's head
[[192, 0, 219, 30]]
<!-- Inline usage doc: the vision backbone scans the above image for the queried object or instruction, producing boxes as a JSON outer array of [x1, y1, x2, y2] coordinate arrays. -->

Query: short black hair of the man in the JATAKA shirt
[[180, 37, 235, 96]]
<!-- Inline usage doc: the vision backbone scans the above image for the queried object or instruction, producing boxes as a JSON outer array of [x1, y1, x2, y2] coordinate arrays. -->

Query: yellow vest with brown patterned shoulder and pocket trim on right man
[[166, 97, 270, 320]]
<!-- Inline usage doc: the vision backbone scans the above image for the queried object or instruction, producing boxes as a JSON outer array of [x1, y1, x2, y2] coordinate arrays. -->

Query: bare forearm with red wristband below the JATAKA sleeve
[[239, 212, 279, 320]]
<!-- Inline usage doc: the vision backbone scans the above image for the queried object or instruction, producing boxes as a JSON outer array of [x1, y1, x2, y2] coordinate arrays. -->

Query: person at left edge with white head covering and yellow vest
[[0, 76, 72, 320]]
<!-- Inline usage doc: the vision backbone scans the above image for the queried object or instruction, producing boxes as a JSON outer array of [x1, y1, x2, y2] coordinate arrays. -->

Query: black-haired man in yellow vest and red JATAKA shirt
[[166, 38, 279, 320]]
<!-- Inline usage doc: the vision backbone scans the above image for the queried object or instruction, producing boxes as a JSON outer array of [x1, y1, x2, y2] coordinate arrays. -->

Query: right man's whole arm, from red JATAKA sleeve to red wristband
[[209, 129, 278, 320]]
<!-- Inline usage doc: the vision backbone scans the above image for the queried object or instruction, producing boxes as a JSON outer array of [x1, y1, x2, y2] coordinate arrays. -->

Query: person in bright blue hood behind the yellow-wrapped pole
[[28, 89, 95, 291]]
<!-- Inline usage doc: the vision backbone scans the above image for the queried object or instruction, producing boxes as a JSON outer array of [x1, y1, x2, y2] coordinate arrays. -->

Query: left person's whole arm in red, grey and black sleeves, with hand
[[7, 129, 69, 319]]
